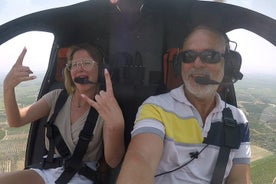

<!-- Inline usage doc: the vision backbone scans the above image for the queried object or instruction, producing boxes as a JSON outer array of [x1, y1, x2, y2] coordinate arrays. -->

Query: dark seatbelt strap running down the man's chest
[[210, 108, 239, 184]]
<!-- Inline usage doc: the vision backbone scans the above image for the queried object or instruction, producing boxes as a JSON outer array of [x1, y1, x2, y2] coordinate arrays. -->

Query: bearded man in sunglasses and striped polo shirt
[[117, 26, 251, 184]]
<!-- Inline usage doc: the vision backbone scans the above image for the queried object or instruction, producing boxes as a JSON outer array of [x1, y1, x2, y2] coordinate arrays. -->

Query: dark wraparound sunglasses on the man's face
[[179, 50, 224, 64]]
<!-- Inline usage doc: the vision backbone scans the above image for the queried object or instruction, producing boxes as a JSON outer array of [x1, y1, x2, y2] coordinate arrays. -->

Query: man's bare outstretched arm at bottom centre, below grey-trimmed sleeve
[[117, 133, 163, 184]]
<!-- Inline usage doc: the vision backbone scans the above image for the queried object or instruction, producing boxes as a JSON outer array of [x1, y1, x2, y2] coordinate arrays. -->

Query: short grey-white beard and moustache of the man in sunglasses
[[183, 69, 224, 99]]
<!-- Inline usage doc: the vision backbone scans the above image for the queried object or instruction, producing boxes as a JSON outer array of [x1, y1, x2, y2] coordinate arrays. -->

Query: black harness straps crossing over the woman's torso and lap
[[40, 90, 98, 184]]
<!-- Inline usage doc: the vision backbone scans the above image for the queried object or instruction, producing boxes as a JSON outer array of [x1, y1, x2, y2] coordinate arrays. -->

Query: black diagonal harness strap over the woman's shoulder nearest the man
[[55, 108, 98, 184]]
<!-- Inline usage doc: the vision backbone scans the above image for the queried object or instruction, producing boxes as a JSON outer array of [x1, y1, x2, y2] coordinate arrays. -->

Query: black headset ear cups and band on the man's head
[[173, 30, 243, 82]]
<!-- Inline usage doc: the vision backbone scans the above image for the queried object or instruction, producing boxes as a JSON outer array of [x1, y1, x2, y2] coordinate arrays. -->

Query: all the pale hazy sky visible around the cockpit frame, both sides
[[0, 0, 276, 75]]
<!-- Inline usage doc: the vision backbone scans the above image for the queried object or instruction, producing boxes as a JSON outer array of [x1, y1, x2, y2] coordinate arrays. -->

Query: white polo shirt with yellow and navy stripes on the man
[[132, 86, 251, 184]]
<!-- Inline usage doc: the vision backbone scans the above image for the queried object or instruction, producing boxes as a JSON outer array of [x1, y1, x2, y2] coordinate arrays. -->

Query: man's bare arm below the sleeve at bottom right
[[226, 164, 250, 184]]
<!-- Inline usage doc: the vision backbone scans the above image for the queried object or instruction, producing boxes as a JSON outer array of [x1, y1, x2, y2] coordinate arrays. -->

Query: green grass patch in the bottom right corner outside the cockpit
[[250, 154, 276, 184]]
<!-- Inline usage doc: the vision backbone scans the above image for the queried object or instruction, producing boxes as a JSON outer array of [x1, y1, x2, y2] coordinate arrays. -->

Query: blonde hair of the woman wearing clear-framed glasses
[[64, 43, 104, 94]]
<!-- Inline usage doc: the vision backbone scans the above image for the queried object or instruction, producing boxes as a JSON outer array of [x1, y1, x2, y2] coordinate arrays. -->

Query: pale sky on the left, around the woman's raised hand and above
[[0, 0, 86, 77]]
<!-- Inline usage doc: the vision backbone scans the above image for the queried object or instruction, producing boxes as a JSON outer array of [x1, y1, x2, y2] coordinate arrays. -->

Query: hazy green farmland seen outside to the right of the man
[[236, 76, 276, 184]]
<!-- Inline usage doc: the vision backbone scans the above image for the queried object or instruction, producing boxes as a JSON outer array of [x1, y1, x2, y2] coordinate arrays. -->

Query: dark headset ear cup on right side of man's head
[[224, 50, 243, 82]]
